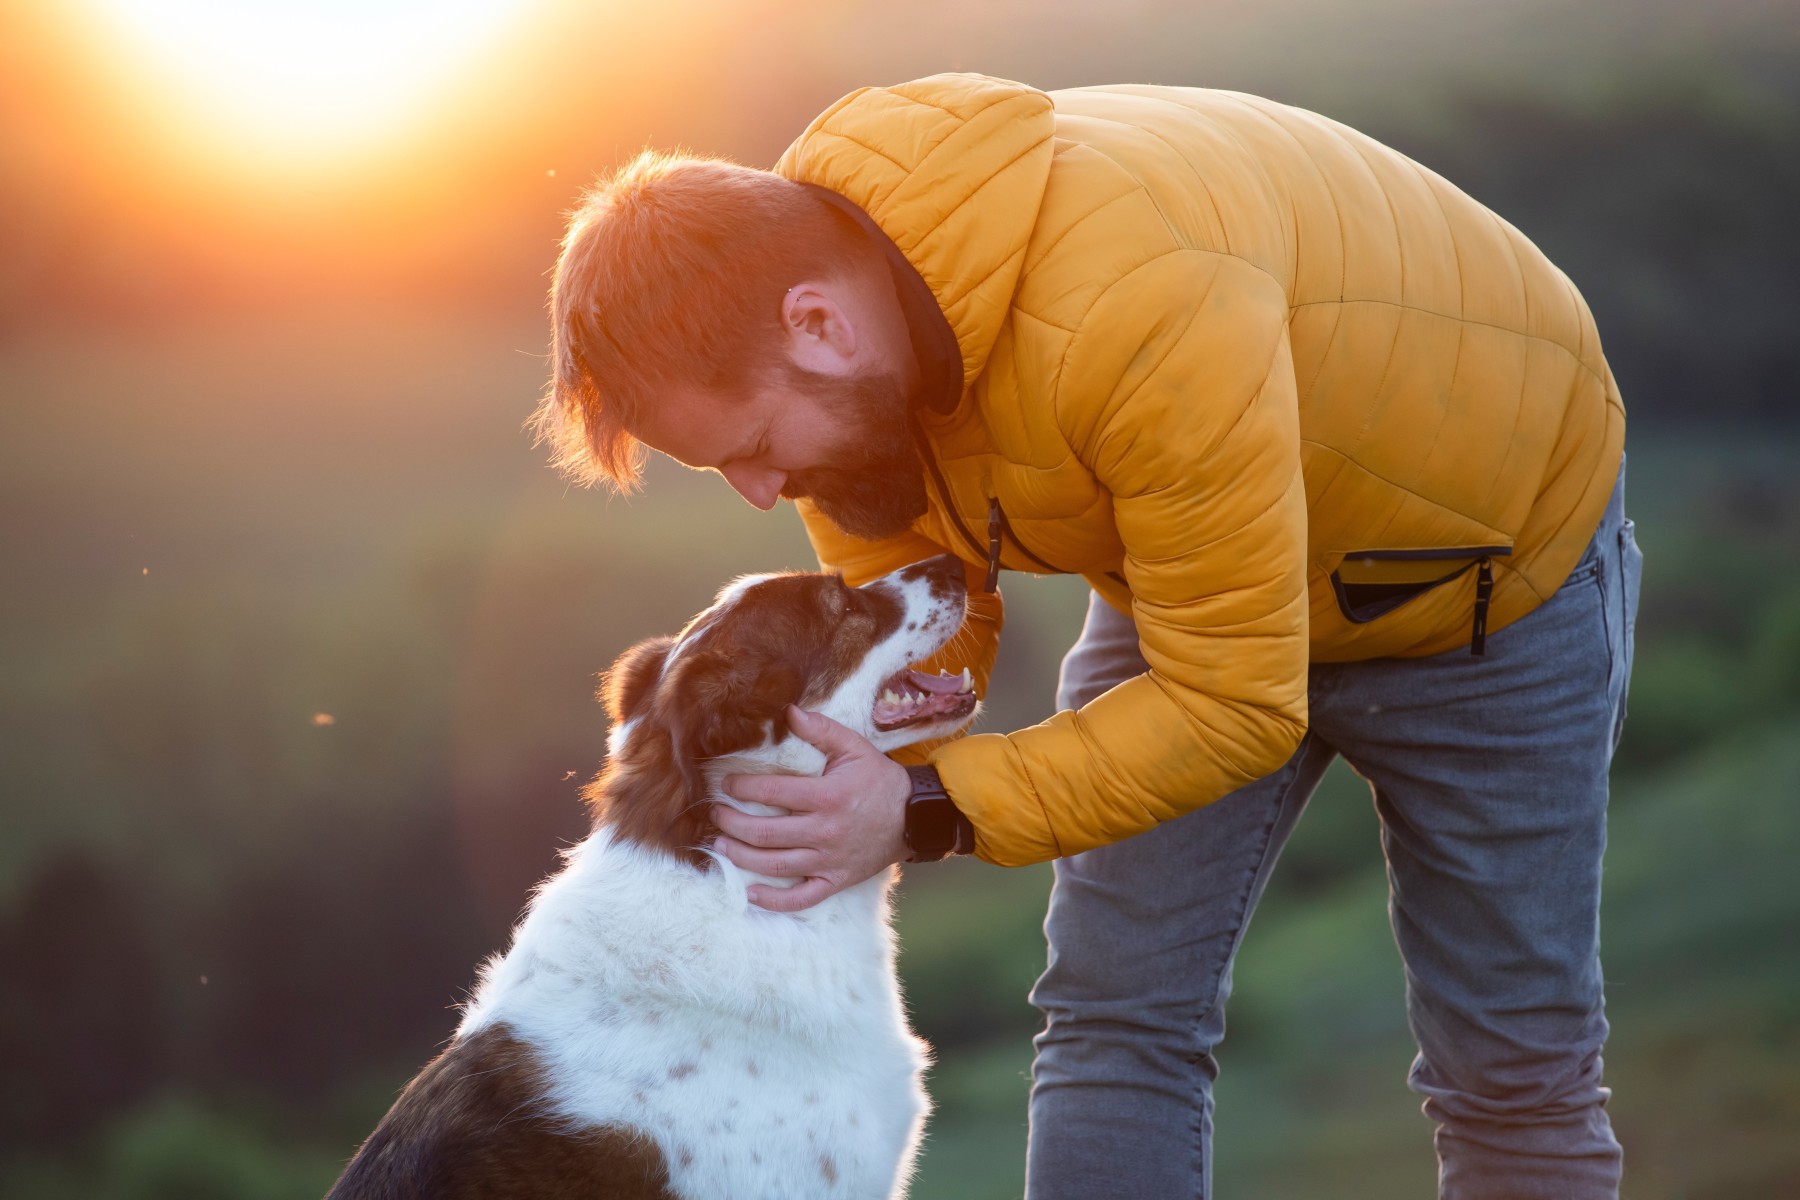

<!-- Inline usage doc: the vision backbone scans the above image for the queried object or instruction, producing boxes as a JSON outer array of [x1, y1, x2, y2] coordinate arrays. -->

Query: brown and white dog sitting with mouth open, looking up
[[328, 556, 979, 1200]]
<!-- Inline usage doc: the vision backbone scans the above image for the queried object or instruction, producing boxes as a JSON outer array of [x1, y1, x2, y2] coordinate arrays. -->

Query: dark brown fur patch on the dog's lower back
[[326, 1025, 675, 1200]]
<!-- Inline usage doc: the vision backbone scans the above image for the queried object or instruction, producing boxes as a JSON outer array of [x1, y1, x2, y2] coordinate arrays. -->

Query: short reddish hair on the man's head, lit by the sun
[[531, 149, 878, 491]]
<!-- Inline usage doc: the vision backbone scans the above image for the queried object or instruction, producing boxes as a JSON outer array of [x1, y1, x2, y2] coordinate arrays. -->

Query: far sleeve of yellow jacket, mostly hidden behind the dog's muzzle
[[794, 500, 1006, 765]]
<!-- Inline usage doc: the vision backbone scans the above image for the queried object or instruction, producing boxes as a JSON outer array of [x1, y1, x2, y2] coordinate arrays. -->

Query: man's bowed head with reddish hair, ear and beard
[[536, 153, 925, 538]]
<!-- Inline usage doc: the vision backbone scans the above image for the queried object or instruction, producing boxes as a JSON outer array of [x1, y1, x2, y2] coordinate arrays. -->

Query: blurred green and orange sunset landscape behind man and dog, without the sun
[[0, 0, 1800, 1200]]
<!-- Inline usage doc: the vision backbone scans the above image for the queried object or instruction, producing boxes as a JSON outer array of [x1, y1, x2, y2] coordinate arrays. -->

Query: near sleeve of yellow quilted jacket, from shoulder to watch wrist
[[932, 250, 1309, 865]]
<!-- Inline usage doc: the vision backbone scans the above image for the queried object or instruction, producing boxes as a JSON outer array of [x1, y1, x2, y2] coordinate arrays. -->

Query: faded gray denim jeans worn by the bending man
[[1026, 471, 1642, 1200]]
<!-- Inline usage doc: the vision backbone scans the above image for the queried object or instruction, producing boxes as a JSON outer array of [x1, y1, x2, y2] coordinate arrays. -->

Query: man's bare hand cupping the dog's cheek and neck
[[713, 705, 913, 912]]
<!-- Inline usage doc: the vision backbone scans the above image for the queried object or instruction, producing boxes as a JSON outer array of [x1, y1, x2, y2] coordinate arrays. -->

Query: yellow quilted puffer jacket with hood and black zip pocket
[[776, 76, 1625, 865]]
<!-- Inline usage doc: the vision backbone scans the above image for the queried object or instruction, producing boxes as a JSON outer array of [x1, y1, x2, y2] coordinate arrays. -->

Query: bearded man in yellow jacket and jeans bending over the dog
[[538, 76, 1640, 1200]]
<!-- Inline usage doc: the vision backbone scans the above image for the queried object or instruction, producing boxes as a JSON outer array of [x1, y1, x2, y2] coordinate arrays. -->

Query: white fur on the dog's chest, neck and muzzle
[[459, 564, 963, 1200]]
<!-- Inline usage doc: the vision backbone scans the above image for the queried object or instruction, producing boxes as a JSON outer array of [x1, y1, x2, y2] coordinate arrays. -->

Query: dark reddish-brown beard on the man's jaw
[[781, 361, 929, 542]]
